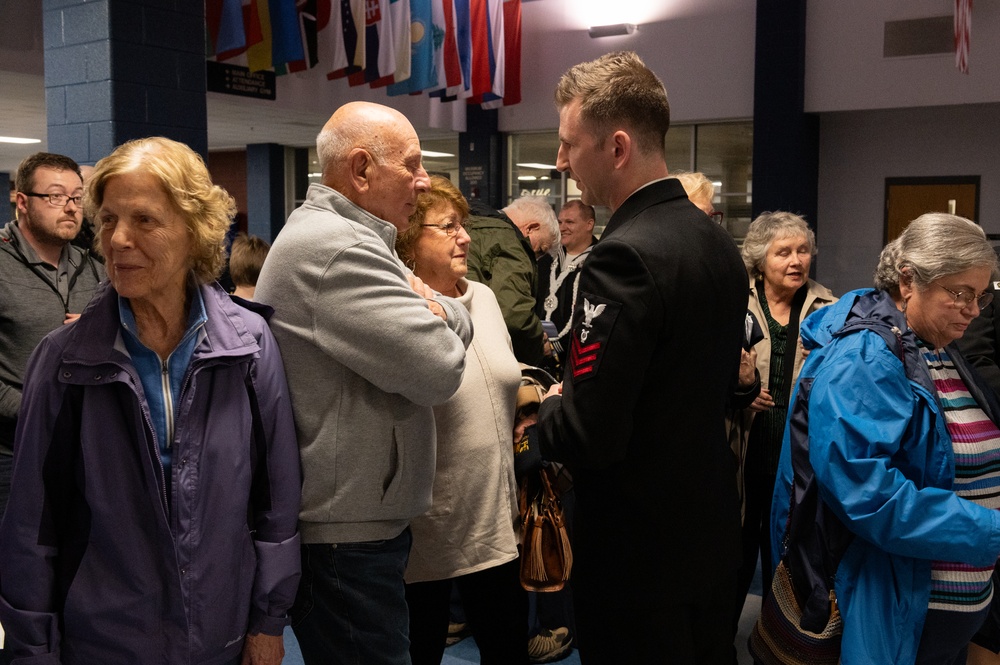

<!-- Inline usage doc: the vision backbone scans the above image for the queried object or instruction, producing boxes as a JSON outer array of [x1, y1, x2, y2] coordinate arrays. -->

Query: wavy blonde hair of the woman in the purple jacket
[[83, 136, 236, 284]]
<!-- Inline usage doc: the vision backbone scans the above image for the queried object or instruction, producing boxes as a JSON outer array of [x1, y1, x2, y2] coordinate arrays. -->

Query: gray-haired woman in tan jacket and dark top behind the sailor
[[735, 212, 836, 620]]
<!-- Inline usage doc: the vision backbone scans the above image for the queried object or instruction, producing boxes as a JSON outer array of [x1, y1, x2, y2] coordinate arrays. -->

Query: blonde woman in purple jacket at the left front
[[0, 138, 300, 665]]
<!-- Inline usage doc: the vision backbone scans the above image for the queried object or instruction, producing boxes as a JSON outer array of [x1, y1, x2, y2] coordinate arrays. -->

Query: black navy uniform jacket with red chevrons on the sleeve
[[539, 179, 747, 600]]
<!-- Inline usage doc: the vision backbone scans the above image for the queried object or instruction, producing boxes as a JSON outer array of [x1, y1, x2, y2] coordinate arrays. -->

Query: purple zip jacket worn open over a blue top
[[0, 283, 301, 665]]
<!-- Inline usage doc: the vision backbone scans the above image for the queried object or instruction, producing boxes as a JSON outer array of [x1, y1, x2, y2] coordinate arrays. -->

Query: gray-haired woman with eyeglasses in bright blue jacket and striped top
[[771, 213, 1000, 665]]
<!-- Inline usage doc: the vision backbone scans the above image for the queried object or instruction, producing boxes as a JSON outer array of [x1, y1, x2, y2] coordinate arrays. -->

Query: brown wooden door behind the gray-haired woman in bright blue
[[882, 176, 979, 243]]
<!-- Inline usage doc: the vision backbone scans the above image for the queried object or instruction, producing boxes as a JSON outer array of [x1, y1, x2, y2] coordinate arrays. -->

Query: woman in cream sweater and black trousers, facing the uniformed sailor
[[396, 176, 528, 665]]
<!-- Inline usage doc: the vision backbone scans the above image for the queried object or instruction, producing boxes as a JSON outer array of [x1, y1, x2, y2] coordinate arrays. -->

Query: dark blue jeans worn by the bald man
[[292, 528, 413, 665]]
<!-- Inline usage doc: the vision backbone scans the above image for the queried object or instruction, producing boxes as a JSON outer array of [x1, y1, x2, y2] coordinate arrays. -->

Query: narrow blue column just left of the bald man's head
[[247, 143, 285, 242]]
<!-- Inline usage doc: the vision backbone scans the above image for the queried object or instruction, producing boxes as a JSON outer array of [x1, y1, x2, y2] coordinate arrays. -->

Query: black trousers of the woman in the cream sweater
[[406, 559, 528, 665]]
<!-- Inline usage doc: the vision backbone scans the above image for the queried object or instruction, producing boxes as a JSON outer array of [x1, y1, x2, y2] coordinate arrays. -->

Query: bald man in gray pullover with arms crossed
[[256, 102, 472, 665]]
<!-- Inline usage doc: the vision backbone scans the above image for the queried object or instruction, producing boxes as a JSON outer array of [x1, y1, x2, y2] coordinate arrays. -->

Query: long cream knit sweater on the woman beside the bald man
[[406, 279, 521, 582]]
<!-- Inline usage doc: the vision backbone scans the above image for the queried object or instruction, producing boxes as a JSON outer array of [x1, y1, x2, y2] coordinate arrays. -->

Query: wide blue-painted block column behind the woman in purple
[[42, 0, 208, 164]]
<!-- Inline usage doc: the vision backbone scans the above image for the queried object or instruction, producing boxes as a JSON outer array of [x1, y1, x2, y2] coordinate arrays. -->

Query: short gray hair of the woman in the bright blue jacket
[[874, 212, 997, 296]]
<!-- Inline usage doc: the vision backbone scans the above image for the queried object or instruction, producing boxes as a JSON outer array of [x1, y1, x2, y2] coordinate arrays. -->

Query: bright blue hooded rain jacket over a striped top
[[771, 289, 1000, 665]]
